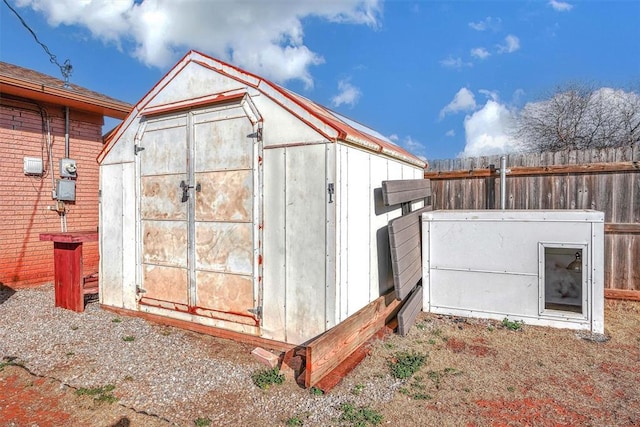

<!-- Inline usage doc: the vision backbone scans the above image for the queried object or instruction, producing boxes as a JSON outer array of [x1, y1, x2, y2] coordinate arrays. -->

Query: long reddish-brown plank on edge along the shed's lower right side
[[305, 292, 400, 388]]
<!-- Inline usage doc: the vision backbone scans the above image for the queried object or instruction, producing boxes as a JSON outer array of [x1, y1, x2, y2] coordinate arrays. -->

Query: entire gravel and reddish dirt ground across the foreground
[[0, 285, 640, 427]]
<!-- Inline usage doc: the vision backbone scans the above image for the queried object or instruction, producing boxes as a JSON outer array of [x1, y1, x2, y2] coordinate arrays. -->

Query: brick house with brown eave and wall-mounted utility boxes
[[0, 62, 131, 288]]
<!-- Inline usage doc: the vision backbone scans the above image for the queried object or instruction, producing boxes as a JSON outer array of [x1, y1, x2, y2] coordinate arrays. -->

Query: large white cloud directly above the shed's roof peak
[[17, 0, 381, 86]]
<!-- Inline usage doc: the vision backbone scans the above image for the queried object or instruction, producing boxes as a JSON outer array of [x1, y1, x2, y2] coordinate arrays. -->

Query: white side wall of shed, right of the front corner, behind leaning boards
[[336, 144, 423, 321]]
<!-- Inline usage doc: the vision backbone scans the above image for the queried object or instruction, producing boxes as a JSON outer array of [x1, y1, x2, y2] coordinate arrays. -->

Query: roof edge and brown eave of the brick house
[[0, 62, 133, 119]]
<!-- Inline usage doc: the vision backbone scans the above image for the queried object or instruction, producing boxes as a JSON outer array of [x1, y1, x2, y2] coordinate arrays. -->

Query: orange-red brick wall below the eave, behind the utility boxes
[[0, 98, 103, 288]]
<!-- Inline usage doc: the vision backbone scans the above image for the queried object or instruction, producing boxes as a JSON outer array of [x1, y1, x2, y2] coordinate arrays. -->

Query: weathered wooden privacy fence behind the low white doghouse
[[425, 146, 640, 300]]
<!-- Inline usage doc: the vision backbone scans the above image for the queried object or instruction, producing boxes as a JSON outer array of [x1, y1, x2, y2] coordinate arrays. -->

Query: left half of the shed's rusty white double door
[[140, 115, 189, 305]]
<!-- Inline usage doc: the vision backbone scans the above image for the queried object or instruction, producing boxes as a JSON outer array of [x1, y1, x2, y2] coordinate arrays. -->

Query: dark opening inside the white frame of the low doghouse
[[544, 247, 584, 313]]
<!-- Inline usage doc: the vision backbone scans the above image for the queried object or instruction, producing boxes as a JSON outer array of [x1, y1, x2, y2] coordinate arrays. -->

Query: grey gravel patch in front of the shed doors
[[0, 285, 400, 425]]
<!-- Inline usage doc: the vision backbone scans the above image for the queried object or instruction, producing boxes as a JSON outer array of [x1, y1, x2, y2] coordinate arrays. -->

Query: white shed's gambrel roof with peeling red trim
[[98, 50, 426, 168]]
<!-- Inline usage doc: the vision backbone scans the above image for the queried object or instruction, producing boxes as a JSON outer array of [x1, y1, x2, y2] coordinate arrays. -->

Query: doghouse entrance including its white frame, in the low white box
[[540, 244, 587, 315]]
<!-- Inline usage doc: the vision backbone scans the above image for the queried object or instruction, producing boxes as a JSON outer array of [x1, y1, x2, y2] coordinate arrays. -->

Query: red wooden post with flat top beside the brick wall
[[40, 231, 98, 312]]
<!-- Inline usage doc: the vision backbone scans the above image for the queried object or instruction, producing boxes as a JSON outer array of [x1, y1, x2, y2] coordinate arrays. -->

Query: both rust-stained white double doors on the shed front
[[136, 105, 260, 325]]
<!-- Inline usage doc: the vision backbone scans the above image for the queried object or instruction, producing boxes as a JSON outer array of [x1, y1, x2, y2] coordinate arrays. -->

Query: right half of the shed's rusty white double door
[[193, 112, 257, 321]]
